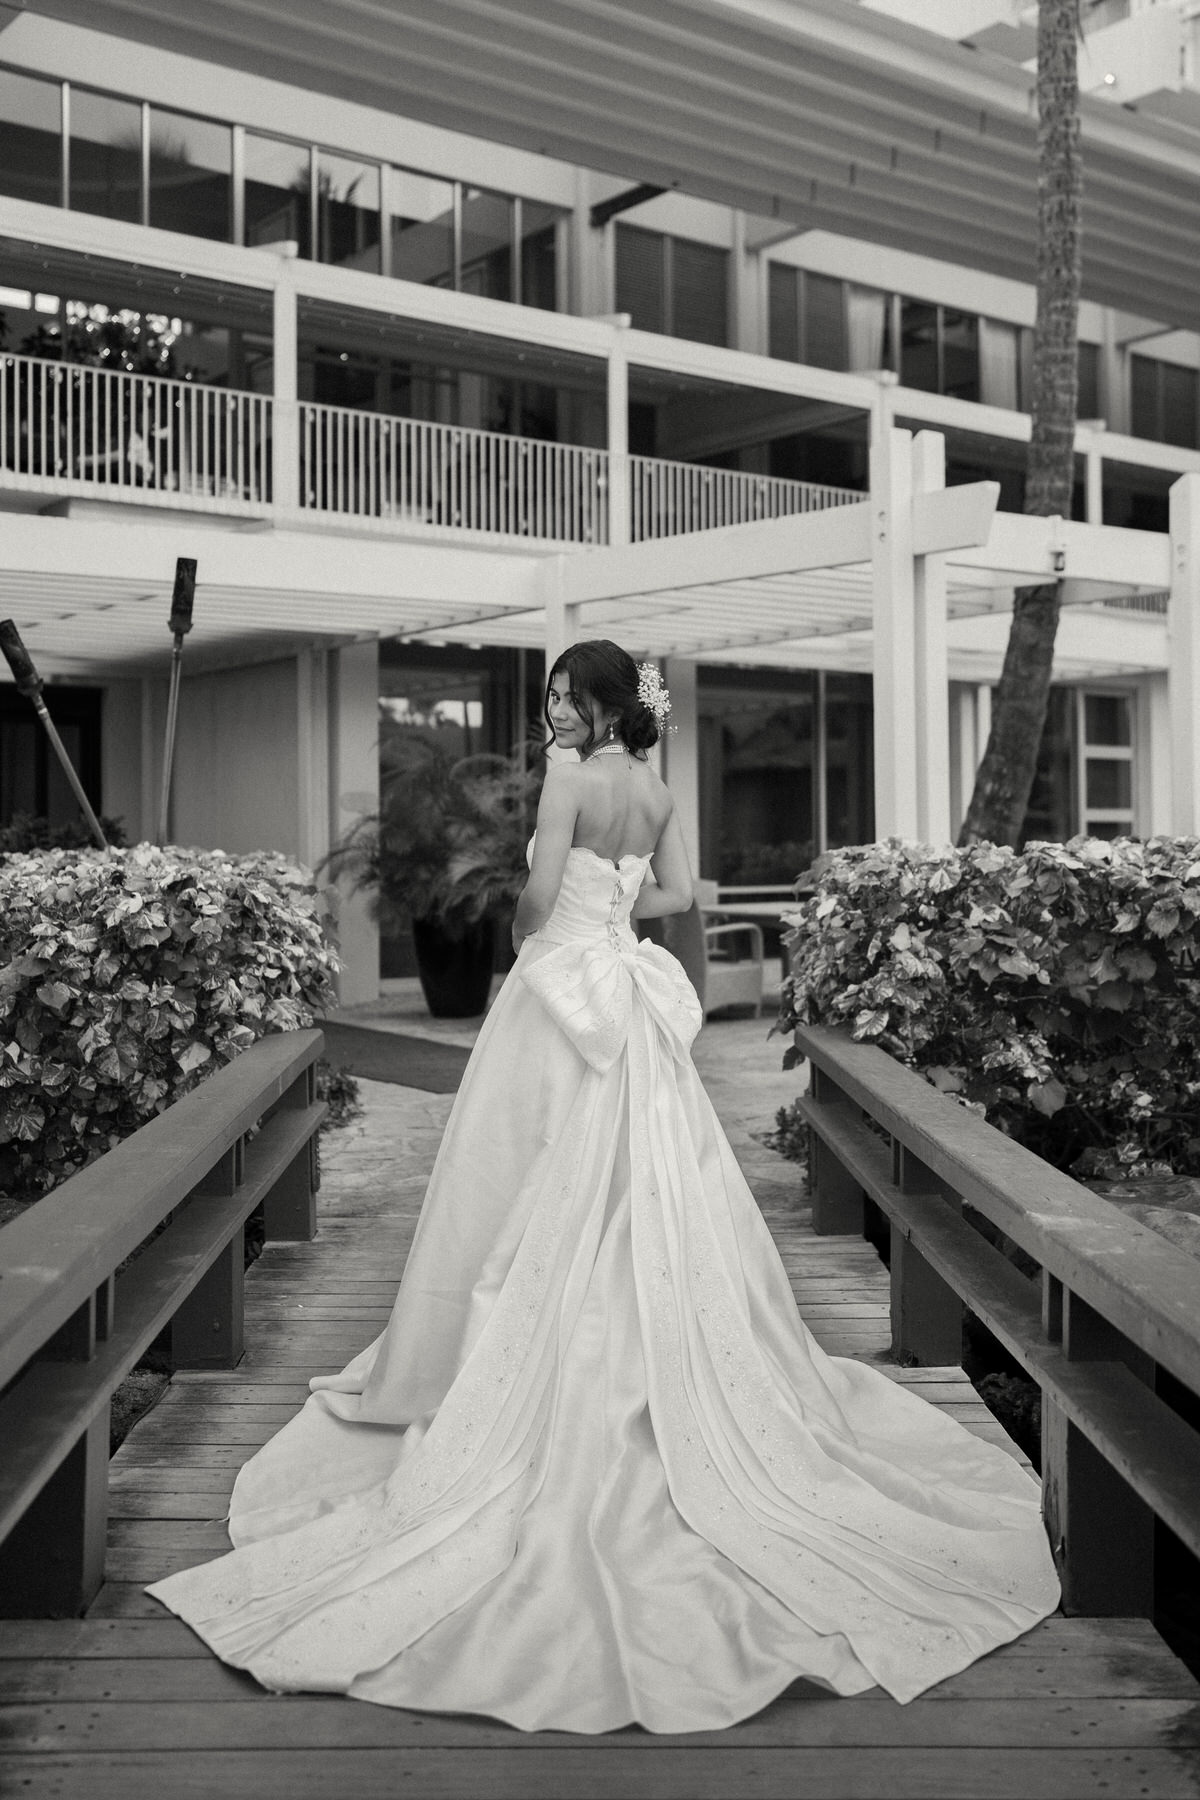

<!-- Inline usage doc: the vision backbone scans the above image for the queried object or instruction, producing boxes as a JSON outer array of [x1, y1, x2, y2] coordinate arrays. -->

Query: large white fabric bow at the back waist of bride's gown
[[518, 941, 703, 1075]]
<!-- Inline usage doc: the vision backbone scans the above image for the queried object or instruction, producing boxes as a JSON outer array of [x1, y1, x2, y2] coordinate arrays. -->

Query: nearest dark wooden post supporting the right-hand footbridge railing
[[1042, 1274, 1155, 1618]]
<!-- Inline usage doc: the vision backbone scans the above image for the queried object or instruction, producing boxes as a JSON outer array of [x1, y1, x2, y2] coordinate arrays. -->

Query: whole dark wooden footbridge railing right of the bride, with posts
[[795, 1028, 1200, 1616]]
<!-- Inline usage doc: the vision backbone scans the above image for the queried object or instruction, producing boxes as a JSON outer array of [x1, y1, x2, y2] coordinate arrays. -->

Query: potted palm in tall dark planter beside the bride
[[324, 727, 542, 1019]]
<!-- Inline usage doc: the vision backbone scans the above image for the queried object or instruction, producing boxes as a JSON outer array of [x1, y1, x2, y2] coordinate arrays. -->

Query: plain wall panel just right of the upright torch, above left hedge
[[171, 661, 302, 857]]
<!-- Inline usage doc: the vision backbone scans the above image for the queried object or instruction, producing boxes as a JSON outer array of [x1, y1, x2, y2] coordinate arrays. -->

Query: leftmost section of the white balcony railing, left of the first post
[[0, 356, 272, 511]]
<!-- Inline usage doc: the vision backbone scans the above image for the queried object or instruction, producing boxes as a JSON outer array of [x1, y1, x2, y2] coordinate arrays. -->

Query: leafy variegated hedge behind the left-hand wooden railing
[[0, 844, 336, 1197]]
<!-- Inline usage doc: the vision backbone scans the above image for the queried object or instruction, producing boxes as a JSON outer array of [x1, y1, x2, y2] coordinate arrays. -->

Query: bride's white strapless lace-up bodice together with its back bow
[[516, 839, 703, 1071]]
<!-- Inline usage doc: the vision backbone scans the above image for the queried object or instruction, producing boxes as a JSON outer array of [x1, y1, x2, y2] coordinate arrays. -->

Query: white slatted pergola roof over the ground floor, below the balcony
[[0, 496, 1169, 680]]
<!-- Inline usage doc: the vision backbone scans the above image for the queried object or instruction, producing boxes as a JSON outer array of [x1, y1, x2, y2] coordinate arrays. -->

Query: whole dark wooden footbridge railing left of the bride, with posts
[[0, 1031, 326, 1618]]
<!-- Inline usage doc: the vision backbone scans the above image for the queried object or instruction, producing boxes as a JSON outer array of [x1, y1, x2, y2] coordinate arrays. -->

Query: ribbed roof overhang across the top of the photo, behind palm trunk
[[14, 0, 1200, 328]]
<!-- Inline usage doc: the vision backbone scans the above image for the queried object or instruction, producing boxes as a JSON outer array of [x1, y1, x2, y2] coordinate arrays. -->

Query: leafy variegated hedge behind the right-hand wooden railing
[[779, 837, 1200, 1175]]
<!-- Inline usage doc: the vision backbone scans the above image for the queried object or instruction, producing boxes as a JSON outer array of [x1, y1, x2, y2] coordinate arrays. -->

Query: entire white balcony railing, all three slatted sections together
[[0, 356, 862, 545]]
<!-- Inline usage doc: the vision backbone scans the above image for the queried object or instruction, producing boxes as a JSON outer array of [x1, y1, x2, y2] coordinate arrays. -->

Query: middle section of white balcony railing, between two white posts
[[300, 403, 608, 544]]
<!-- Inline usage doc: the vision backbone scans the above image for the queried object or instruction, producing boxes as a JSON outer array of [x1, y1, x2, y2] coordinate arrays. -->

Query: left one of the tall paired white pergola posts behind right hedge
[[871, 428, 921, 839]]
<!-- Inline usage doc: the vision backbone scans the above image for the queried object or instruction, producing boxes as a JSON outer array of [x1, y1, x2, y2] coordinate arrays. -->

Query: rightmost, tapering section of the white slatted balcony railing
[[630, 455, 864, 544]]
